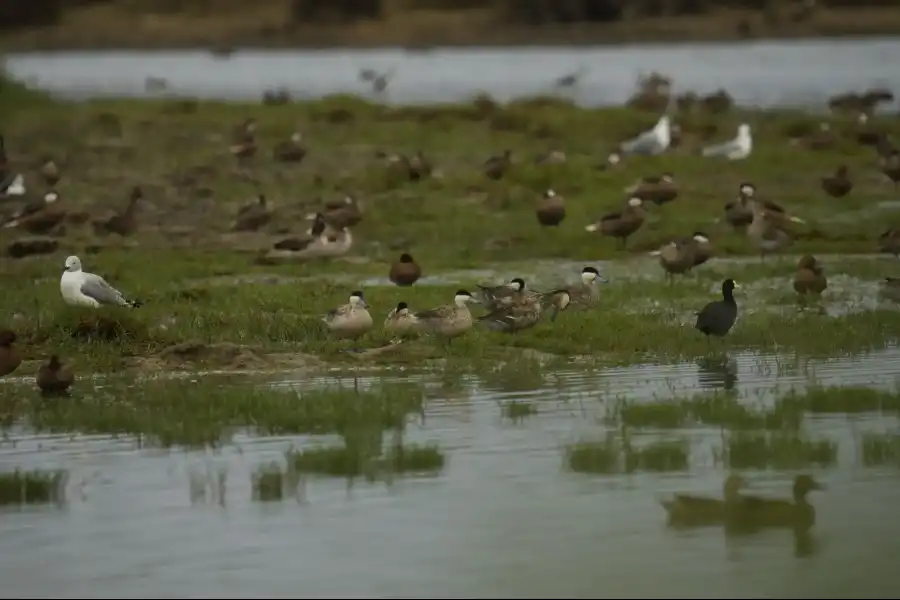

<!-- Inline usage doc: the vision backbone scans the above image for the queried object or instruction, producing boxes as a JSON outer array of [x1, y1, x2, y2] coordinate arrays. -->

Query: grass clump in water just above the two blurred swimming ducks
[[722, 432, 838, 470]]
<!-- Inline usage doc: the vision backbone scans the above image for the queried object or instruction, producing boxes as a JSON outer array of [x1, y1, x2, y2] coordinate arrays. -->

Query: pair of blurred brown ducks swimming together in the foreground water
[[660, 474, 824, 532]]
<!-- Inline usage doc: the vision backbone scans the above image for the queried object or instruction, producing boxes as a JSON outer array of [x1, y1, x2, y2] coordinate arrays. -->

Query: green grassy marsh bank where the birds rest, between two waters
[[0, 79, 900, 369]]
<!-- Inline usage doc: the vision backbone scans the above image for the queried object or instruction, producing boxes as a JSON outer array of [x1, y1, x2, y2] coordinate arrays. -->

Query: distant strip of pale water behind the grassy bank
[[6, 38, 900, 106]]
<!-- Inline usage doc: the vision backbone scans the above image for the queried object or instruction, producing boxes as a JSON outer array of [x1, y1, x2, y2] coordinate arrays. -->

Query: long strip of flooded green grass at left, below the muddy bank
[[0, 376, 423, 447]]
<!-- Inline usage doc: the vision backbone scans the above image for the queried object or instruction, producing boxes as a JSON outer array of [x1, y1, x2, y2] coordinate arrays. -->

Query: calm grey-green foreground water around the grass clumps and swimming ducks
[[0, 349, 900, 598]]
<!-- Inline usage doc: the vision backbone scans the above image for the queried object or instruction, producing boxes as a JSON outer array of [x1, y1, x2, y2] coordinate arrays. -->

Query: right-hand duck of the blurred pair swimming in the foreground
[[734, 475, 825, 531]]
